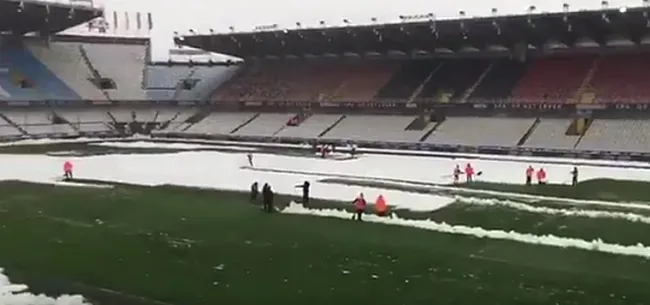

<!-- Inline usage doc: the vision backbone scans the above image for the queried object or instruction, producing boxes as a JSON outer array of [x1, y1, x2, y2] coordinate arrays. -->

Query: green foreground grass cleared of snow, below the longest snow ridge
[[0, 182, 650, 305]]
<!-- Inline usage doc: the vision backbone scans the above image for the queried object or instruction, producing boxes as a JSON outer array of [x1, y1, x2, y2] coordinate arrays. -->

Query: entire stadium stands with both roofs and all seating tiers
[[0, 0, 650, 160]]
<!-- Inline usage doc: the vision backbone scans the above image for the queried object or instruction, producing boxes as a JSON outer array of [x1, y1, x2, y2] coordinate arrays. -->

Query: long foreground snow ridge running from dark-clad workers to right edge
[[282, 202, 650, 258]]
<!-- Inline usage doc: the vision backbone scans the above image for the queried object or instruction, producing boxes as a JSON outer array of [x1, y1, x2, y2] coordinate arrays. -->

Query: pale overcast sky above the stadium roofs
[[81, 0, 643, 59]]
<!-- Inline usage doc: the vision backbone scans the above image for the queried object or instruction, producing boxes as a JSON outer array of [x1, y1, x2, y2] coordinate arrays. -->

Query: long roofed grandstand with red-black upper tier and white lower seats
[[165, 8, 650, 159]]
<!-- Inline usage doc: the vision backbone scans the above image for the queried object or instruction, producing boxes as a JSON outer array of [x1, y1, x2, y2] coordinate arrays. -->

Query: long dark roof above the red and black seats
[[176, 7, 650, 59]]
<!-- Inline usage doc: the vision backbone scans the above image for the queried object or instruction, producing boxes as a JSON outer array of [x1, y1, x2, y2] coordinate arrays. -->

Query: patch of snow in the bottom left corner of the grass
[[0, 268, 90, 305]]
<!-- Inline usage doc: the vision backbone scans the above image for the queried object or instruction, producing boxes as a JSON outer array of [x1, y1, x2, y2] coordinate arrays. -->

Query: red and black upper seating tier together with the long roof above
[[178, 8, 650, 103]]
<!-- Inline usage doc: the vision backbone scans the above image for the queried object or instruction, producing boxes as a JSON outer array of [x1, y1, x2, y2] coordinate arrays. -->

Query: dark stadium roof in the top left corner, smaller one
[[0, 0, 103, 35]]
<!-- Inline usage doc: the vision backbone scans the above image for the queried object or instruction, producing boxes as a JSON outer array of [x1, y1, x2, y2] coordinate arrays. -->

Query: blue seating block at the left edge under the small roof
[[0, 49, 81, 100]]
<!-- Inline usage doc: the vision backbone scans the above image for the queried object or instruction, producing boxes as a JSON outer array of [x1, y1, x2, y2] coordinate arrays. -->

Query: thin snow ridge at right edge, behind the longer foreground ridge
[[456, 196, 650, 224]]
